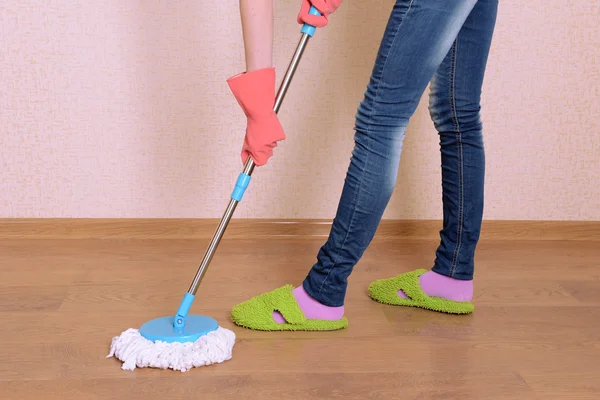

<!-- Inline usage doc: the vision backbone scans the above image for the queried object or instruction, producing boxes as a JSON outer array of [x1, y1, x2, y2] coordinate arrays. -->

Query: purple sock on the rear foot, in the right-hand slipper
[[398, 271, 473, 301]]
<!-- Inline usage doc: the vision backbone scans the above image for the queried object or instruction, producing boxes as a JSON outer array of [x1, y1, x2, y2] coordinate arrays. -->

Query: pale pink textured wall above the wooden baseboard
[[0, 0, 600, 220]]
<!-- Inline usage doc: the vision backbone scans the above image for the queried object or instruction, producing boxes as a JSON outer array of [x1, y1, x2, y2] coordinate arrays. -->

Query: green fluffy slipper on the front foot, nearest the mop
[[231, 285, 348, 331]]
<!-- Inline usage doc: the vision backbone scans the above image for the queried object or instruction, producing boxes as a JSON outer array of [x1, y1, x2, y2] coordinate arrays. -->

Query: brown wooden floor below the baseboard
[[0, 239, 600, 400]]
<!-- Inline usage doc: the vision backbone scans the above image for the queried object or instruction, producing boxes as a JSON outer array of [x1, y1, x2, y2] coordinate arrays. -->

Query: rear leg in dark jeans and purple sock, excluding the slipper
[[372, 0, 498, 312]]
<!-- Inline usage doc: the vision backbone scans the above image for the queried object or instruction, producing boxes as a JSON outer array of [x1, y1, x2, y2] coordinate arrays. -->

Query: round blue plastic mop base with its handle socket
[[140, 293, 219, 343]]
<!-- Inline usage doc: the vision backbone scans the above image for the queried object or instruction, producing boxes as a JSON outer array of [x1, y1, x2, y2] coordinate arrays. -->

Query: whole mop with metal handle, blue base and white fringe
[[107, 6, 321, 372]]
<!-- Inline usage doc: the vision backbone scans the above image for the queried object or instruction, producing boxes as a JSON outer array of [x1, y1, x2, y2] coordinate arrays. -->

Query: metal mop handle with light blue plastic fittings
[[185, 6, 321, 296]]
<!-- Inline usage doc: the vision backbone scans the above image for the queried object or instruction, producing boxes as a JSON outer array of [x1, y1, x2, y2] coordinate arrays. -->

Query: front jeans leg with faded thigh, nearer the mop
[[303, 0, 491, 306]]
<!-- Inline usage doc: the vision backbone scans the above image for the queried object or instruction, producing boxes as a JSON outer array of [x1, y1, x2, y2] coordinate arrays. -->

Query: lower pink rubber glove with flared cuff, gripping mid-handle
[[227, 68, 285, 166]]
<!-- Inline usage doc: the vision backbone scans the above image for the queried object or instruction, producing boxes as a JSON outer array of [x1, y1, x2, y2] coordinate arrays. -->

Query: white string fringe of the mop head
[[106, 327, 235, 372]]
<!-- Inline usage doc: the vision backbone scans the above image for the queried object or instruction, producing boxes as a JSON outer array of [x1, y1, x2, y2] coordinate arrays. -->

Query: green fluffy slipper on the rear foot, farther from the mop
[[369, 269, 475, 314]]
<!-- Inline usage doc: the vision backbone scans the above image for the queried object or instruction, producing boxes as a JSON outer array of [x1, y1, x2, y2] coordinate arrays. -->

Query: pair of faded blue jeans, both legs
[[303, 0, 498, 306]]
